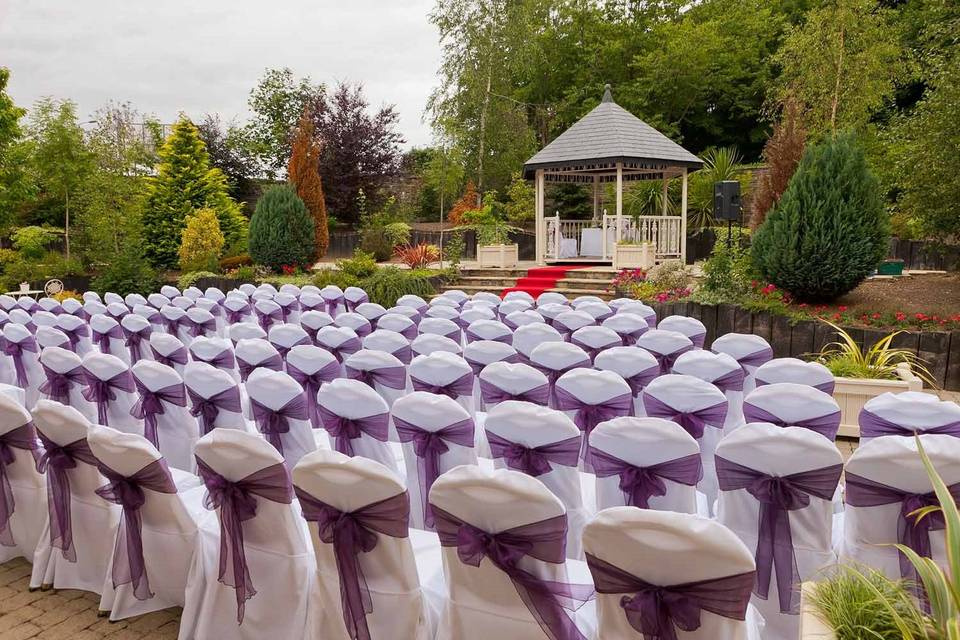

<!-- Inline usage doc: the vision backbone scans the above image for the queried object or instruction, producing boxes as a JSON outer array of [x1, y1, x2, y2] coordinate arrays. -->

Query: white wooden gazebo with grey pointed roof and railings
[[523, 85, 703, 264]]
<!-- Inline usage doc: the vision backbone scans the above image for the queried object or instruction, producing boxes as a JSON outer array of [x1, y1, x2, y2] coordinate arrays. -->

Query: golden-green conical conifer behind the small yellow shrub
[[143, 117, 246, 268]]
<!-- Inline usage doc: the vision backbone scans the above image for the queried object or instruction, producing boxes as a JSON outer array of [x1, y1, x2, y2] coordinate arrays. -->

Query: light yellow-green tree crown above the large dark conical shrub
[[776, 0, 906, 134]]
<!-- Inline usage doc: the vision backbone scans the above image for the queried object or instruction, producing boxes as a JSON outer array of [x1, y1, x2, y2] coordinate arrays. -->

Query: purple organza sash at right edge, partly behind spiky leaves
[[844, 471, 960, 592]]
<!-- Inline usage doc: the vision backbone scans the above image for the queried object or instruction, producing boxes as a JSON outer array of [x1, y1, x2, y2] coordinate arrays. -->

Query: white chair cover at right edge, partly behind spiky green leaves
[[840, 434, 960, 600]]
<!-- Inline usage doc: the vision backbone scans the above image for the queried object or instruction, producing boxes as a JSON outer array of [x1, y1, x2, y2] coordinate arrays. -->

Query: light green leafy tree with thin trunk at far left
[[27, 98, 95, 259]]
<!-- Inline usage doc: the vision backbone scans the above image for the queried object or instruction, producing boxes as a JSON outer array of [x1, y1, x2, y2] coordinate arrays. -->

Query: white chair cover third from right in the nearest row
[[293, 451, 436, 640]]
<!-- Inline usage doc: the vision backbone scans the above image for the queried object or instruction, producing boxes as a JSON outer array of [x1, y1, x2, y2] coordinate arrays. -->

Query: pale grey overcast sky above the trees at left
[[0, 0, 440, 146]]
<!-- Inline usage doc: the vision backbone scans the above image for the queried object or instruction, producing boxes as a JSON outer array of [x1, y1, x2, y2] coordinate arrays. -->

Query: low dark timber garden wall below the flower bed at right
[[650, 301, 960, 391]]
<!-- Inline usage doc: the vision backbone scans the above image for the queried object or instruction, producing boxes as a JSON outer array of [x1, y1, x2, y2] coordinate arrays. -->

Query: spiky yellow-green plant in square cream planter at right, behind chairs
[[817, 322, 931, 438]]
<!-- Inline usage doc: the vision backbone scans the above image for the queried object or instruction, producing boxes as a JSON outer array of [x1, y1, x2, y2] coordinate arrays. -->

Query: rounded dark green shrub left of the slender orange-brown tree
[[250, 185, 315, 271]]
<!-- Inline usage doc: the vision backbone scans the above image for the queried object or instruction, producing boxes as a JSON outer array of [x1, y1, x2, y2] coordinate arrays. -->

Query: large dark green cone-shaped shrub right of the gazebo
[[752, 134, 889, 301]]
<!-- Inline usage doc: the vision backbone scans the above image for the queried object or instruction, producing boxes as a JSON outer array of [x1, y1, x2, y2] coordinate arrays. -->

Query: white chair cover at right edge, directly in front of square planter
[[860, 391, 960, 443]]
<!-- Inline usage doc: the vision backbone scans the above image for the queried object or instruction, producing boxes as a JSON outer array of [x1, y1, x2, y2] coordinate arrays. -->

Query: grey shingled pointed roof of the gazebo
[[523, 85, 703, 178]]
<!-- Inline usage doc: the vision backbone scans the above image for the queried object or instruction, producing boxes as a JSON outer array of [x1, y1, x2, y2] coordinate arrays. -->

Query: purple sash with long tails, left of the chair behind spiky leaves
[[715, 456, 843, 614]]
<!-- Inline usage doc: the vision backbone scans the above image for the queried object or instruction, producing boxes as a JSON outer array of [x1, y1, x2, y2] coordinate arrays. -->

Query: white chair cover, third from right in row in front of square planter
[[643, 373, 727, 514]]
